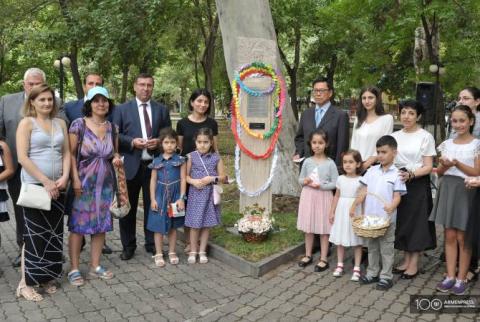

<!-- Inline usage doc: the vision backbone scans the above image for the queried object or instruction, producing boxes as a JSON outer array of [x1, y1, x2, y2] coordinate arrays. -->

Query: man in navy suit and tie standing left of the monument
[[113, 74, 172, 260]]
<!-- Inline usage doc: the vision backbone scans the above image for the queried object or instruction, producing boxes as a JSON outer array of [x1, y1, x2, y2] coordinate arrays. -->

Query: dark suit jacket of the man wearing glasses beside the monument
[[295, 105, 350, 166]]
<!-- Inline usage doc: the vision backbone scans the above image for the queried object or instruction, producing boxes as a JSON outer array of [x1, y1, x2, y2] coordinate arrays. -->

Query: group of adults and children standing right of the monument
[[293, 78, 480, 295]]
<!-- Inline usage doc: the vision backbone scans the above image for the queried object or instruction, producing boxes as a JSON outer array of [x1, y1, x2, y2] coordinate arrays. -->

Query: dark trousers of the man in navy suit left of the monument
[[119, 161, 155, 251]]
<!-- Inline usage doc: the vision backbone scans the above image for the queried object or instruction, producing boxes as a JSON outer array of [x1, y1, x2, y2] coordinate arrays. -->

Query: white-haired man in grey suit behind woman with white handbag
[[0, 68, 65, 267]]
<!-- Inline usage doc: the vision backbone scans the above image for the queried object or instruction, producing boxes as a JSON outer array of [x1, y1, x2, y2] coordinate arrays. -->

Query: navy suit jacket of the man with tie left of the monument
[[113, 99, 172, 180]]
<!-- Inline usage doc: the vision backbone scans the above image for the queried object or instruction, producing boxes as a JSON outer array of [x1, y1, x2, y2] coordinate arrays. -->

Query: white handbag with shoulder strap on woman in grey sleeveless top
[[17, 120, 55, 211]]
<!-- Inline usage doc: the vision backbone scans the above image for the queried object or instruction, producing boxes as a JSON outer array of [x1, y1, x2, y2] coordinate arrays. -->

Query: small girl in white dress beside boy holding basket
[[329, 150, 363, 282]]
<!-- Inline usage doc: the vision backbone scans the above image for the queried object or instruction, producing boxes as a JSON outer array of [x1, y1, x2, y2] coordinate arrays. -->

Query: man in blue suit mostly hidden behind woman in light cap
[[65, 72, 112, 254]]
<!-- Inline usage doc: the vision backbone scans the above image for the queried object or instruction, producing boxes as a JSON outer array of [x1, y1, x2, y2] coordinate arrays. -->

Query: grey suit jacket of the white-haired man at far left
[[0, 92, 66, 169]]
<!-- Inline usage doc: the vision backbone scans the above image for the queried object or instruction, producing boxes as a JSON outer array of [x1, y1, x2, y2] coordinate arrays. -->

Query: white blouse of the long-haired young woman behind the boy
[[350, 114, 393, 160]]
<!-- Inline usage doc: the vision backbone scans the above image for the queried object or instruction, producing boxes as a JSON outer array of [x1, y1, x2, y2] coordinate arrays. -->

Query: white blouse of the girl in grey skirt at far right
[[437, 139, 480, 178]]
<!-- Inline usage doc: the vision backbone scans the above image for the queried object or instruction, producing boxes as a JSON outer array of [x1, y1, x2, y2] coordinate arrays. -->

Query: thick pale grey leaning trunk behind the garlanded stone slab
[[216, 0, 300, 195]]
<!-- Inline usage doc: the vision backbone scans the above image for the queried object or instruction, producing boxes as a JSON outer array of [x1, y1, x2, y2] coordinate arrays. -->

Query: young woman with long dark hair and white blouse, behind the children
[[350, 86, 393, 170]]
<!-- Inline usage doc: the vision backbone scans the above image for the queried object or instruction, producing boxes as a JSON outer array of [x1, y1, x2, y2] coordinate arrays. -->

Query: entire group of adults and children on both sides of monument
[[0, 68, 480, 301]]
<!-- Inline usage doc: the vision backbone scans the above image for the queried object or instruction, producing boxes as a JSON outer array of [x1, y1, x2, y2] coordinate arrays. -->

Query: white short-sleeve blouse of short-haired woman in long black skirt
[[392, 129, 437, 171]]
